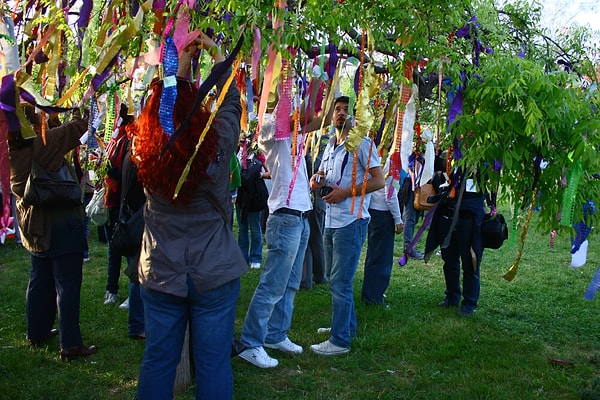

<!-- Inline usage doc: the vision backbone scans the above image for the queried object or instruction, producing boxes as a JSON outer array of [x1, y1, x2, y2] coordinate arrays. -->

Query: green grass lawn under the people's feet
[[0, 216, 600, 400]]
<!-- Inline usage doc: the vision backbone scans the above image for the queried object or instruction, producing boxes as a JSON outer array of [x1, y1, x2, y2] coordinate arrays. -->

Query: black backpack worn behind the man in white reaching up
[[236, 158, 269, 212]]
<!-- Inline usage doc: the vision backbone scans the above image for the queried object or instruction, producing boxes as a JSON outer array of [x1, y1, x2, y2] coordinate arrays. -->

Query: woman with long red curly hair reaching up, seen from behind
[[134, 34, 247, 400]]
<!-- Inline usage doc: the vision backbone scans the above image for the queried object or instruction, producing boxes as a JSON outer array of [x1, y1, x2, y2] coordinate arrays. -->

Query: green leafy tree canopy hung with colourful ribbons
[[7, 0, 600, 234]]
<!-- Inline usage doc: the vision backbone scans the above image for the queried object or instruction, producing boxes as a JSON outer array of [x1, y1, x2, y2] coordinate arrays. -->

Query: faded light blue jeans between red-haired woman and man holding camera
[[242, 214, 310, 348]]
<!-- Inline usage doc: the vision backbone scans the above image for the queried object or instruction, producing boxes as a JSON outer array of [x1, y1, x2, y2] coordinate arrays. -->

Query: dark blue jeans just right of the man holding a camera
[[361, 209, 396, 304]]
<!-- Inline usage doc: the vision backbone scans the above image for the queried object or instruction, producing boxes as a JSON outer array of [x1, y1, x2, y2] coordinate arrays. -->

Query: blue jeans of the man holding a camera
[[323, 219, 369, 347]]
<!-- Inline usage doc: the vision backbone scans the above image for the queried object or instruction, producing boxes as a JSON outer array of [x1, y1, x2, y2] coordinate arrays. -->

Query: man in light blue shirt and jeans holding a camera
[[310, 96, 385, 355]]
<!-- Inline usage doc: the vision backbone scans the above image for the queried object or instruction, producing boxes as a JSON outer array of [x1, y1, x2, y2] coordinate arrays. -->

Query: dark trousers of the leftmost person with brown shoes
[[26, 252, 83, 348]]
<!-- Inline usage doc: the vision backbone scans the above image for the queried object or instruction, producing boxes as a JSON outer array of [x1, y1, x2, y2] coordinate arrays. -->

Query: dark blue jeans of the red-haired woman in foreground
[[138, 278, 240, 400]]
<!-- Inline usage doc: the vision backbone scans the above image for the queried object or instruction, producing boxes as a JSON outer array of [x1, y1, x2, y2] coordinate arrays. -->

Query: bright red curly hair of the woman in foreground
[[127, 79, 219, 204]]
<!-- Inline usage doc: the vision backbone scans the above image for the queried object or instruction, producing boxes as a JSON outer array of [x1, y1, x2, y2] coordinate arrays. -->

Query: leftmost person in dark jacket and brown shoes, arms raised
[[8, 107, 97, 360]]
